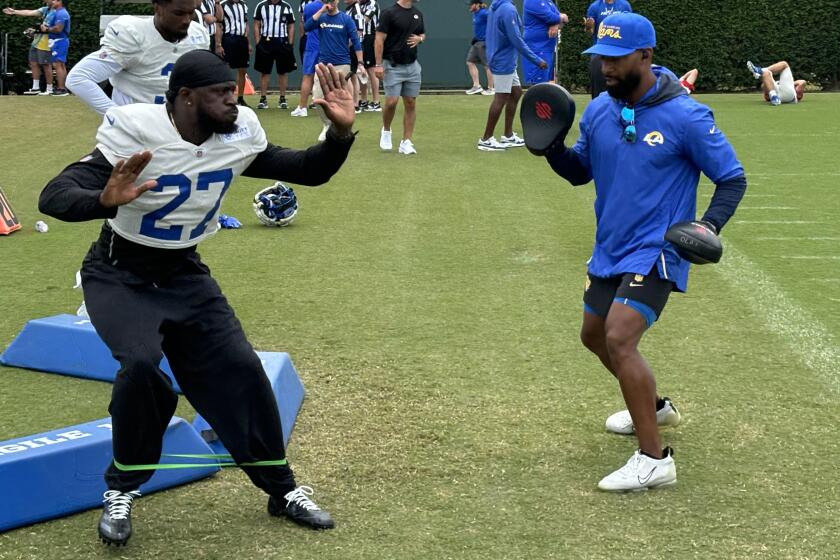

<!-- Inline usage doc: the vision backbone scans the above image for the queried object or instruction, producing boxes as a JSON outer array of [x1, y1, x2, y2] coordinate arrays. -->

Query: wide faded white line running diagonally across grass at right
[[715, 244, 840, 391]]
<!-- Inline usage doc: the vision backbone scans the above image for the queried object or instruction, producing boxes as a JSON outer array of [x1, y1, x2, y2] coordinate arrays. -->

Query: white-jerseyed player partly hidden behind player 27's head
[[67, 0, 210, 114]]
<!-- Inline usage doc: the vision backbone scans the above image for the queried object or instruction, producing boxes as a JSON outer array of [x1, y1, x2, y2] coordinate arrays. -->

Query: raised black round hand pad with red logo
[[519, 84, 575, 156]]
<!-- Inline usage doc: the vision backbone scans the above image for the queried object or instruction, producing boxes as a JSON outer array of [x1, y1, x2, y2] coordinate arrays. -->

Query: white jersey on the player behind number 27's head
[[100, 16, 210, 105]]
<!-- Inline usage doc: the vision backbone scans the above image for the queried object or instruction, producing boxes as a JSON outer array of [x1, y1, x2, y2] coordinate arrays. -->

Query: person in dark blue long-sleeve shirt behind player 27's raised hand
[[303, 0, 367, 142]]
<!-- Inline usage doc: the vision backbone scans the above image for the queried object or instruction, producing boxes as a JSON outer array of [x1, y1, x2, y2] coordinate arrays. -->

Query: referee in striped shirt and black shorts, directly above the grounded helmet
[[254, 0, 297, 109]]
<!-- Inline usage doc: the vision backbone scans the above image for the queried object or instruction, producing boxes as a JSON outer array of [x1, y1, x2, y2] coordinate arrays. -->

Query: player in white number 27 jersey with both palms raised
[[39, 50, 355, 544]]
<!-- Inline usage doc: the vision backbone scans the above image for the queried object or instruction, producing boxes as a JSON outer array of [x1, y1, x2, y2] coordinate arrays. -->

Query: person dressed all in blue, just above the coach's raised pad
[[522, 0, 569, 84]]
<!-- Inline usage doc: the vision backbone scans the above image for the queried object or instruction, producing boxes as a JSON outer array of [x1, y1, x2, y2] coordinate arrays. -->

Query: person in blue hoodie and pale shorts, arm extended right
[[477, 0, 548, 152]]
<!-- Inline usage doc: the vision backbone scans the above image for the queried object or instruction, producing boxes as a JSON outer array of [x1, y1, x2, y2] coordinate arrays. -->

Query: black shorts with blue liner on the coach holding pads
[[583, 265, 674, 327]]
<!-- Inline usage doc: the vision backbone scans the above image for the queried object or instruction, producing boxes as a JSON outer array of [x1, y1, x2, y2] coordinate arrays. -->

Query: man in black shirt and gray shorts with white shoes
[[373, 0, 426, 155]]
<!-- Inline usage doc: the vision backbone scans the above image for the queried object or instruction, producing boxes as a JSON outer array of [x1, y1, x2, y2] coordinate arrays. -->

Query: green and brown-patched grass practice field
[[0, 94, 840, 560]]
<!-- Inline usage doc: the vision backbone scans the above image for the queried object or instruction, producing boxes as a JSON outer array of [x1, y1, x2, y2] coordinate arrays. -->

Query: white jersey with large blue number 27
[[96, 103, 268, 249]]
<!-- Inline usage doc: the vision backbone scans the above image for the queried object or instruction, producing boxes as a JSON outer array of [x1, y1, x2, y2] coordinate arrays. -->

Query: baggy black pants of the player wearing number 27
[[82, 224, 295, 496]]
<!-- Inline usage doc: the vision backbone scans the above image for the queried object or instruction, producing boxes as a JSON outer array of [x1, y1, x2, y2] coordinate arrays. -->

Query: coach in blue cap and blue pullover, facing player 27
[[546, 13, 747, 491]]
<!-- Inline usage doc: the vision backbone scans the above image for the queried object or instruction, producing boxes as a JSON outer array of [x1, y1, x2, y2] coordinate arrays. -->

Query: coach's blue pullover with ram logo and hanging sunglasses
[[572, 68, 744, 292]]
